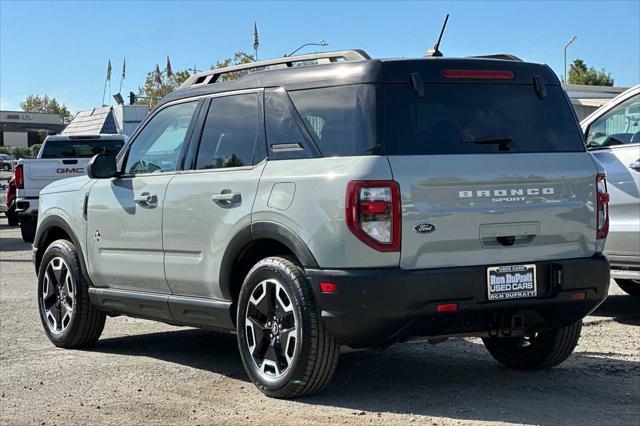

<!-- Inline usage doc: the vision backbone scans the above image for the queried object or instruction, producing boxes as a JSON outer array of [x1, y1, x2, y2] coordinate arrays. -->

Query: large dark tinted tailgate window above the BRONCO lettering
[[384, 83, 585, 155]]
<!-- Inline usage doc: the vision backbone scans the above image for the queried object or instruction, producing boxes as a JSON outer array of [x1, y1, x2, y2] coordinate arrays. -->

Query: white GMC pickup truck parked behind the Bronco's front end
[[15, 134, 127, 243]]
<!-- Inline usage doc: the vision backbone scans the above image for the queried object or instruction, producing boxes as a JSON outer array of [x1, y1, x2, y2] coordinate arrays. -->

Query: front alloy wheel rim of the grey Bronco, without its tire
[[40, 257, 75, 334]]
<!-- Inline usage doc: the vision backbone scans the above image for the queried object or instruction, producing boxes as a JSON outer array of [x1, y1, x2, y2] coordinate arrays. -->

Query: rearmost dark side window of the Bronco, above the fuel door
[[289, 84, 376, 157]]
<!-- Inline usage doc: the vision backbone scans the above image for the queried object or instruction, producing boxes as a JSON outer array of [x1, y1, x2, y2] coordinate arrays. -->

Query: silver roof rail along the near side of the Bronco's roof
[[180, 49, 371, 89]]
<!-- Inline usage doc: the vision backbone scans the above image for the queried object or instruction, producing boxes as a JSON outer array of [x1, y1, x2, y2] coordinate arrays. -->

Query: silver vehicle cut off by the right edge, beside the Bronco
[[581, 85, 640, 297]]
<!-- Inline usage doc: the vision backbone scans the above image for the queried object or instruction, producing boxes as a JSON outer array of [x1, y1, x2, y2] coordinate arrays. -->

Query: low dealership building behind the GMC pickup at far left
[[0, 111, 66, 147]]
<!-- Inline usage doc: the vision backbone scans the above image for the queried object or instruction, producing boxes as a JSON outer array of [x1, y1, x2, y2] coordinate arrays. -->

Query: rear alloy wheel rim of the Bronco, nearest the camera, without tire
[[245, 279, 299, 380]]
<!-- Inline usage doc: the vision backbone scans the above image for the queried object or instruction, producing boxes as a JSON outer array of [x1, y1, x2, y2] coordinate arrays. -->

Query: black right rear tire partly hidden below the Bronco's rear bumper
[[482, 321, 582, 370]]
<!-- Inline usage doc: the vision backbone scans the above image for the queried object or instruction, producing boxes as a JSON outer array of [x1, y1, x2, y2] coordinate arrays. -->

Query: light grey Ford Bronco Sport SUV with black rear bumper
[[34, 51, 609, 398]]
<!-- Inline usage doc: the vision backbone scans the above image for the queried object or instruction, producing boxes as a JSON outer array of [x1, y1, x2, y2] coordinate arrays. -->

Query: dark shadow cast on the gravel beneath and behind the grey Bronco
[[94, 296, 640, 425]]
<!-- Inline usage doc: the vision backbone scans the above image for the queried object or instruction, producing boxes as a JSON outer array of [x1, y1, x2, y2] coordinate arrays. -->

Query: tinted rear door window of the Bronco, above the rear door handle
[[196, 93, 260, 170]]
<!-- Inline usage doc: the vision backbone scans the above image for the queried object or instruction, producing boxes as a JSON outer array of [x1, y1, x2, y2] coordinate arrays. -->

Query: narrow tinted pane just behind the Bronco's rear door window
[[265, 89, 314, 159]]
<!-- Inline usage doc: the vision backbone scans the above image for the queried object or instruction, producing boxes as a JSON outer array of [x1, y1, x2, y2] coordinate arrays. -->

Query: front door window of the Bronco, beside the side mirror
[[125, 101, 198, 174]]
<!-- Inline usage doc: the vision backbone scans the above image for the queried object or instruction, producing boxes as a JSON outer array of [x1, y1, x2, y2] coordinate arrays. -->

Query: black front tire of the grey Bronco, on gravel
[[38, 240, 106, 349]]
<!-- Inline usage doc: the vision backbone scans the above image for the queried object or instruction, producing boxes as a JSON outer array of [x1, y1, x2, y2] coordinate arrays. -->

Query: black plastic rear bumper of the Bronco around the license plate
[[306, 254, 609, 348]]
